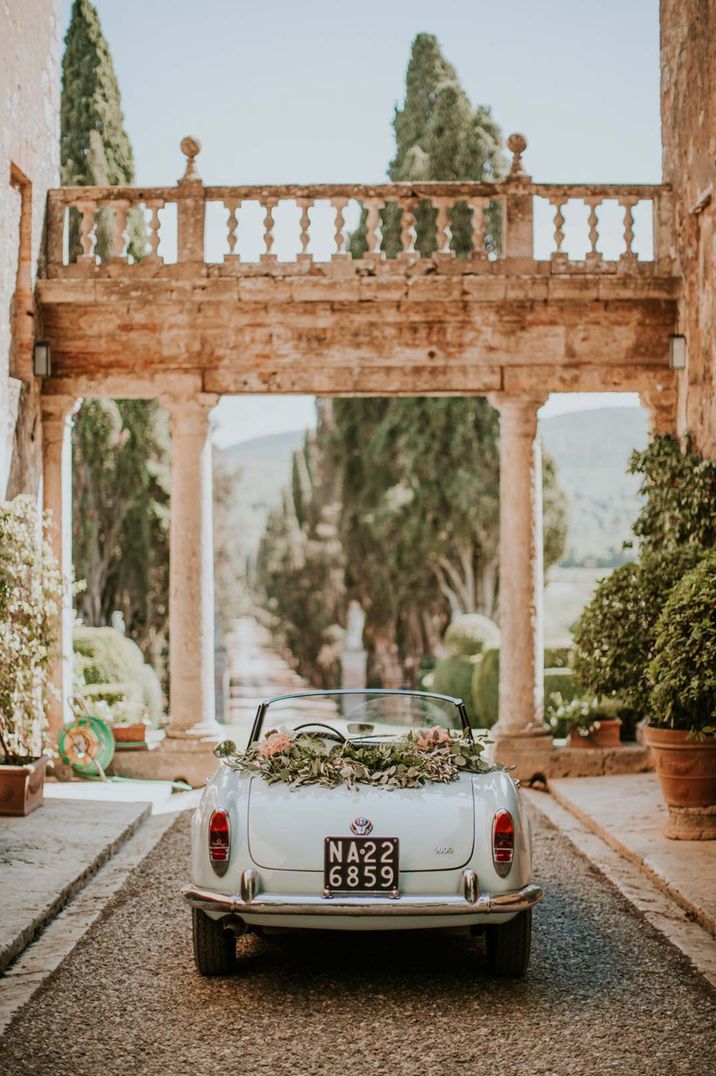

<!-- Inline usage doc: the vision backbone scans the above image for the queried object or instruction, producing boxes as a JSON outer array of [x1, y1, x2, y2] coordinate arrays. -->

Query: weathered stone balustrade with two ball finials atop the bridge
[[46, 136, 671, 278]]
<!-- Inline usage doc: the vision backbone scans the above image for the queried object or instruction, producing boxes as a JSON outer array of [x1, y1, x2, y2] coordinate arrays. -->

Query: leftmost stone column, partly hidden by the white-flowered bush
[[42, 396, 81, 745]]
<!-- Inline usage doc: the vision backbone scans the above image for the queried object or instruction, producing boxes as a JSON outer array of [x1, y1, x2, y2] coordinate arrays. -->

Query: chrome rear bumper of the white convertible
[[182, 884, 545, 917]]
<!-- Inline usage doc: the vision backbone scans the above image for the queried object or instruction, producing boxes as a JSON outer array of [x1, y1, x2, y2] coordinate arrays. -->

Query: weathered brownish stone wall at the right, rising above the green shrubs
[[661, 0, 716, 456]]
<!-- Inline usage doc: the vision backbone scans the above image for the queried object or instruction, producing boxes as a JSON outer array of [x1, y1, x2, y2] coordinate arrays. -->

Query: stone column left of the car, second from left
[[162, 393, 220, 738]]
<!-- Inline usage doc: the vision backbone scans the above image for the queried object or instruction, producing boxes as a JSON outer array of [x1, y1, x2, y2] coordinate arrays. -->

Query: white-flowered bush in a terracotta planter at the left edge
[[0, 496, 64, 815]]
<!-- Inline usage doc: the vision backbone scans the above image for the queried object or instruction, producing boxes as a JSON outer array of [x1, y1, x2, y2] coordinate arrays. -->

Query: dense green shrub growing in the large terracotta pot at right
[[648, 550, 716, 733]]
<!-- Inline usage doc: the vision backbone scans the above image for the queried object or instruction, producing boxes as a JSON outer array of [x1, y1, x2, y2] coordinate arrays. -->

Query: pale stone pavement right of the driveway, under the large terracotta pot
[[542, 774, 716, 935]]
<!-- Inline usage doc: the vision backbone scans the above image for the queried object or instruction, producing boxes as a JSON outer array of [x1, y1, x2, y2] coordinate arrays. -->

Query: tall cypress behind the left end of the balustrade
[[60, 0, 169, 666]]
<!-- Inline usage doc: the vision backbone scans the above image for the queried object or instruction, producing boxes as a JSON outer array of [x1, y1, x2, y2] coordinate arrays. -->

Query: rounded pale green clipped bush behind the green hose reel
[[73, 624, 163, 721]]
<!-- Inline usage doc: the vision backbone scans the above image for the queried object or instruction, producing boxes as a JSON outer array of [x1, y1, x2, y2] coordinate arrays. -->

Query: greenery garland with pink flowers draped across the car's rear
[[215, 726, 502, 789]]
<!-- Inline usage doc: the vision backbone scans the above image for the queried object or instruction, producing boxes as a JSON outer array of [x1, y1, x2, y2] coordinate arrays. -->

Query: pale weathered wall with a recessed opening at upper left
[[0, 0, 60, 497]]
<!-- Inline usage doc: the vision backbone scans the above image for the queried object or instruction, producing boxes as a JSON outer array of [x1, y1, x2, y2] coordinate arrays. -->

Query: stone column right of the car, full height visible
[[490, 393, 548, 741]]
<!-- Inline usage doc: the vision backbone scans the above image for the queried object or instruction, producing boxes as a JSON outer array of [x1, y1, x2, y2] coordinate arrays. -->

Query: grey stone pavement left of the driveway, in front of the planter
[[0, 792, 151, 972]]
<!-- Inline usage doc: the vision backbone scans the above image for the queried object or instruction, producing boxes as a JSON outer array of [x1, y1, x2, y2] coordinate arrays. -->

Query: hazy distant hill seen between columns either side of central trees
[[215, 408, 647, 565]]
